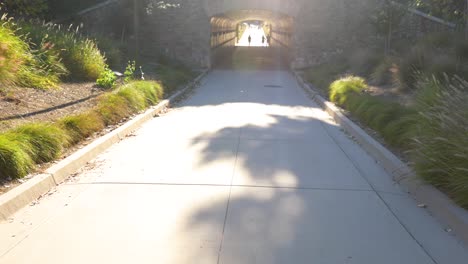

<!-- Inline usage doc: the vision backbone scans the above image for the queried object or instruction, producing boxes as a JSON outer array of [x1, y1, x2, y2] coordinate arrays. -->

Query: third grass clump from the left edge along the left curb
[[58, 111, 105, 144]]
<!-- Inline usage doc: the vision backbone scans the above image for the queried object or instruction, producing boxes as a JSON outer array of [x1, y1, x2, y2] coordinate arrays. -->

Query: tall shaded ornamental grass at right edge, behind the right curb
[[412, 75, 468, 208]]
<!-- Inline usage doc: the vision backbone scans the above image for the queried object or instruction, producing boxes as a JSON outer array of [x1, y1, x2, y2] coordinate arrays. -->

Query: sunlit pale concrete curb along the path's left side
[[0, 70, 209, 221]]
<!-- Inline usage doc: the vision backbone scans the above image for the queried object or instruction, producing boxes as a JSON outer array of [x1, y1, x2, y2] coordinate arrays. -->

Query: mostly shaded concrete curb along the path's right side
[[294, 72, 468, 245]]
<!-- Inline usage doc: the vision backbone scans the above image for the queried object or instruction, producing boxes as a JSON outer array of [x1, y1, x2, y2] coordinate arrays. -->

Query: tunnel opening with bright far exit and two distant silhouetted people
[[210, 10, 293, 70]]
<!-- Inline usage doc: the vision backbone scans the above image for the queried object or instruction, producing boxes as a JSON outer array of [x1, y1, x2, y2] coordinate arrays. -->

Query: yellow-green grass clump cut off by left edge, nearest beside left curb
[[0, 134, 34, 180]]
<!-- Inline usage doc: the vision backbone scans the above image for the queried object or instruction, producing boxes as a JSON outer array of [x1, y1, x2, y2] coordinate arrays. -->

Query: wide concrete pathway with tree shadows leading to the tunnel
[[0, 71, 468, 264]]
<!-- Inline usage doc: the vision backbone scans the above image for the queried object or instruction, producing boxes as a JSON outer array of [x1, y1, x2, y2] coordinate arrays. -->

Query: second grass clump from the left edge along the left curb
[[12, 123, 69, 163]]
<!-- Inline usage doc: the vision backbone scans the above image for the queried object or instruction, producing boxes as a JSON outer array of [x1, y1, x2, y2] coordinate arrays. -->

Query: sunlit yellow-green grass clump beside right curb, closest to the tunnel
[[330, 76, 368, 106]]
